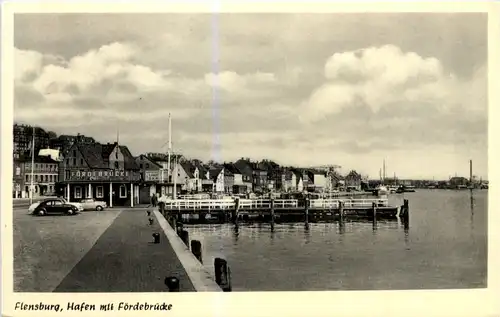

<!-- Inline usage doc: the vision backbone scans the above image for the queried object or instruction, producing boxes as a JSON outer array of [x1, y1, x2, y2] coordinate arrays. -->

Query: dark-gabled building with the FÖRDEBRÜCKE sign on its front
[[58, 142, 141, 207]]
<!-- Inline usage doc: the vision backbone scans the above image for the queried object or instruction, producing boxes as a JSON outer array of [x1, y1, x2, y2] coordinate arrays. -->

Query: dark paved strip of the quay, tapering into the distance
[[54, 209, 195, 292]]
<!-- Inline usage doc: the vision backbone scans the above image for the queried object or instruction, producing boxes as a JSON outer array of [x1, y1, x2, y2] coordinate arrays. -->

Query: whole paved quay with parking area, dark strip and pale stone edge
[[13, 207, 220, 292]]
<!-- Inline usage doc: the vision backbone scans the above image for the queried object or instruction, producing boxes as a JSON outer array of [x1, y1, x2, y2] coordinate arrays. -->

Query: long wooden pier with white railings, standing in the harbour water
[[158, 198, 399, 225]]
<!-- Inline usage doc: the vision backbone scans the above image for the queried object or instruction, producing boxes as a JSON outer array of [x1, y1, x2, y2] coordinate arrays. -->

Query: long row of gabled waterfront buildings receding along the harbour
[[13, 128, 361, 206]]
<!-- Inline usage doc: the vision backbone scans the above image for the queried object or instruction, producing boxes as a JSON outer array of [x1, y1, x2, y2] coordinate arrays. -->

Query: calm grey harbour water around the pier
[[187, 190, 488, 291]]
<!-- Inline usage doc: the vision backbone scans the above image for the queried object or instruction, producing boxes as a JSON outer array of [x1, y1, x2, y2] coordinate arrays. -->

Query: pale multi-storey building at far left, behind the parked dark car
[[18, 156, 59, 198]]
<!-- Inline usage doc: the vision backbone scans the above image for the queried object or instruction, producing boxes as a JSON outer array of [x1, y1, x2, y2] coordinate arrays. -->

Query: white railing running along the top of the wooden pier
[[160, 199, 389, 210]]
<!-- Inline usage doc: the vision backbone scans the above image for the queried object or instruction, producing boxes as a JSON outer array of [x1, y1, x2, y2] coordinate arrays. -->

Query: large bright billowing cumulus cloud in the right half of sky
[[301, 45, 485, 122]]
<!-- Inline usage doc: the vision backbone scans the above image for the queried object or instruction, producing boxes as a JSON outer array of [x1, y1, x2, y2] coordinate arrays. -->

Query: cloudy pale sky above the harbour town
[[14, 13, 488, 179]]
